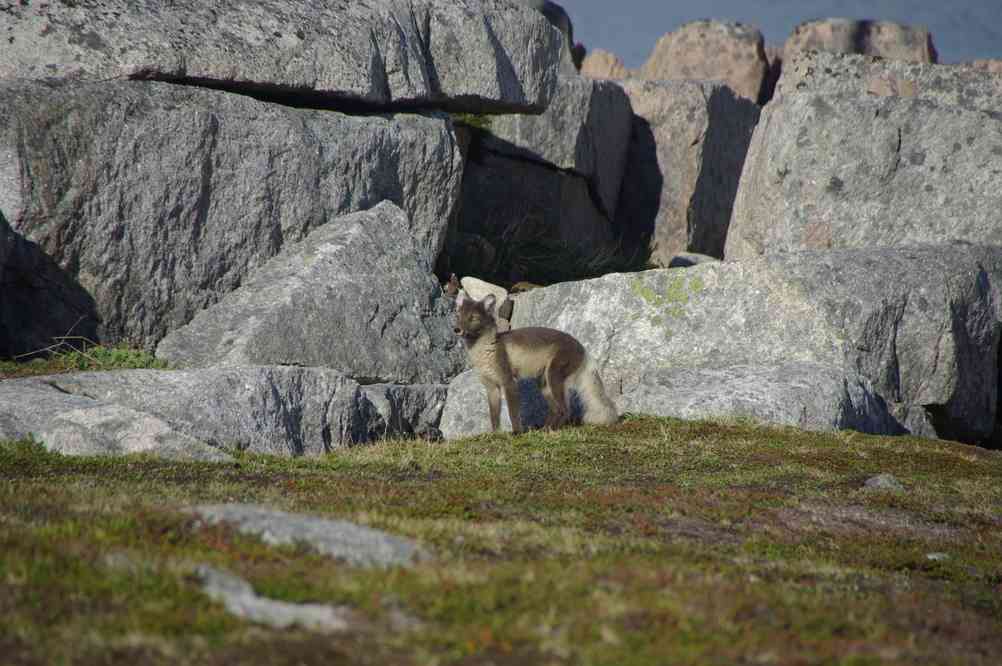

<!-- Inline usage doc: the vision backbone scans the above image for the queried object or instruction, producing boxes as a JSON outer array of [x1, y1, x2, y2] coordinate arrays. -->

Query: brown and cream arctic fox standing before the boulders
[[456, 295, 615, 433]]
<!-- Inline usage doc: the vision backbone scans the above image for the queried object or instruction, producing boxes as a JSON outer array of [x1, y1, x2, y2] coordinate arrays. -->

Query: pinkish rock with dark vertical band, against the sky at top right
[[784, 18, 938, 62]]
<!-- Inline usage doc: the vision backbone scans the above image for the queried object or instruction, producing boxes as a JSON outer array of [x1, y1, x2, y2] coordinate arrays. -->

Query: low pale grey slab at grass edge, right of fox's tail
[[618, 363, 904, 435]]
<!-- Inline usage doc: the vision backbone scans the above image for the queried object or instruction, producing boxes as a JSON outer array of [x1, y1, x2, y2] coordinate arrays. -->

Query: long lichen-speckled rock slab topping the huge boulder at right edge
[[777, 51, 1002, 112]]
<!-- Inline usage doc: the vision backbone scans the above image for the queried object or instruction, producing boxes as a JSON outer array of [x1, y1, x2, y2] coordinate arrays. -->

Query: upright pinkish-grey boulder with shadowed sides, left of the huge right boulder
[[616, 79, 759, 266]]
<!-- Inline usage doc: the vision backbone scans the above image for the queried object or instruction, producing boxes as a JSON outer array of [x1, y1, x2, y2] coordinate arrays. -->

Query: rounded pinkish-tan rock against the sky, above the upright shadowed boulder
[[640, 20, 769, 101]]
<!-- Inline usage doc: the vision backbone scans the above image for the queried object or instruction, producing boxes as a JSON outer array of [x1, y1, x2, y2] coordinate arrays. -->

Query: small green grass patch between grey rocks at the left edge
[[0, 345, 167, 380]]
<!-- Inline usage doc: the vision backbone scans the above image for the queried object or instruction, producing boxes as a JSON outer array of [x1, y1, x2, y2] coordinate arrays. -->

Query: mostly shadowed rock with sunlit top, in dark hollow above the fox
[[447, 74, 632, 282]]
